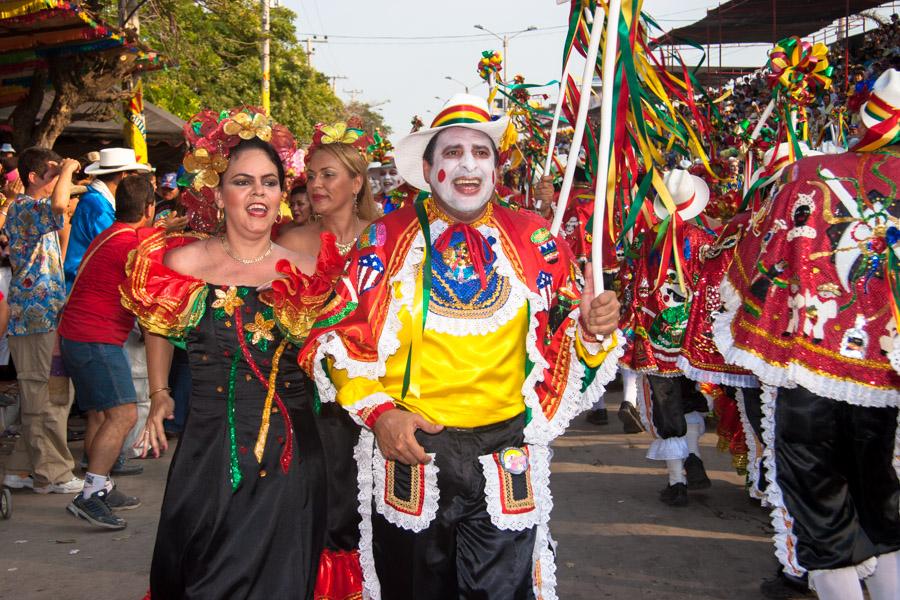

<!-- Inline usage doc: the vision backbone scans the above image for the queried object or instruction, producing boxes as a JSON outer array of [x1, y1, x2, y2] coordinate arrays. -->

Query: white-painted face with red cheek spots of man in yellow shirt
[[428, 127, 496, 213]]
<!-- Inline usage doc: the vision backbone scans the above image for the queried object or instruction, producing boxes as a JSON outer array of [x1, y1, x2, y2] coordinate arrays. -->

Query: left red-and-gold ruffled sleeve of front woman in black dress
[[119, 229, 207, 338]]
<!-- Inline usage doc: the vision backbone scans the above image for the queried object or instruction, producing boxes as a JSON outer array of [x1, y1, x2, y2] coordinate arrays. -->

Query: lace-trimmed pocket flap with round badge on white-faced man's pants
[[478, 446, 548, 531]]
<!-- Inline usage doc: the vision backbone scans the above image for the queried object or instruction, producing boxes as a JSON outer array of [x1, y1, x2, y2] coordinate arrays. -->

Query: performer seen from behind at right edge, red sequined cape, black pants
[[714, 73, 900, 581]]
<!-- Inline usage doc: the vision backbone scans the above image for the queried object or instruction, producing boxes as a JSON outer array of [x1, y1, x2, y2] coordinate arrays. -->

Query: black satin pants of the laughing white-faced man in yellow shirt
[[372, 415, 536, 600]]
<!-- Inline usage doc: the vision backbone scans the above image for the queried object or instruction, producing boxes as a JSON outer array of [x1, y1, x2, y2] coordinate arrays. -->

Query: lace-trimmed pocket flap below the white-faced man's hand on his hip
[[372, 449, 438, 531]]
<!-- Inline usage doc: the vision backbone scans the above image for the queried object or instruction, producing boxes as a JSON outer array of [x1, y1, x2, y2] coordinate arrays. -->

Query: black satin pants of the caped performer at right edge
[[775, 387, 900, 570]]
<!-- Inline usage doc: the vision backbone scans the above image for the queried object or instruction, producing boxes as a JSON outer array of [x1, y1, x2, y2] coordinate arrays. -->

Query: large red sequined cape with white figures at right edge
[[715, 151, 900, 406]]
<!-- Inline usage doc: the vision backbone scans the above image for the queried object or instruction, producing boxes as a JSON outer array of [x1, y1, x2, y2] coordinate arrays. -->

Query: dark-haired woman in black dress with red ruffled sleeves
[[122, 109, 334, 600]]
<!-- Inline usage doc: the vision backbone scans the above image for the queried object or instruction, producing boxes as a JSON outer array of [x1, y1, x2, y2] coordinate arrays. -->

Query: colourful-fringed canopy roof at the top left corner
[[0, 0, 162, 107]]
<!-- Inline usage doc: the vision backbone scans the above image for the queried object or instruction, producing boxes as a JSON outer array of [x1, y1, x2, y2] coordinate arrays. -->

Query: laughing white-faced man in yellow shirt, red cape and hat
[[301, 95, 623, 599]]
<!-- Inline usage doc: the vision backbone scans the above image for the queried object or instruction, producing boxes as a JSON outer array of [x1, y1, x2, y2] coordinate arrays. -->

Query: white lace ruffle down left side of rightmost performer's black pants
[[761, 385, 806, 577]]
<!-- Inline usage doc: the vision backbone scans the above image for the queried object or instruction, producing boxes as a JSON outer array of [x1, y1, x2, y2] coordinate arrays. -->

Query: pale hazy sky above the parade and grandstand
[[281, 0, 889, 141]]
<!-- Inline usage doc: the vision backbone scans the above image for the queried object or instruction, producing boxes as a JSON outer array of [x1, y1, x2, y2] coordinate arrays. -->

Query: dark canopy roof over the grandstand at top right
[[658, 0, 886, 45]]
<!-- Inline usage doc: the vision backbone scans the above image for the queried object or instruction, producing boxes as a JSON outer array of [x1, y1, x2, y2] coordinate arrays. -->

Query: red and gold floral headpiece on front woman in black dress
[[178, 106, 302, 233]]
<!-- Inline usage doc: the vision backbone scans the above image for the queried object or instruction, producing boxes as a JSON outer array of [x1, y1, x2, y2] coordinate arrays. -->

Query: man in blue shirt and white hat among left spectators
[[65, 148, 150, 294]]
